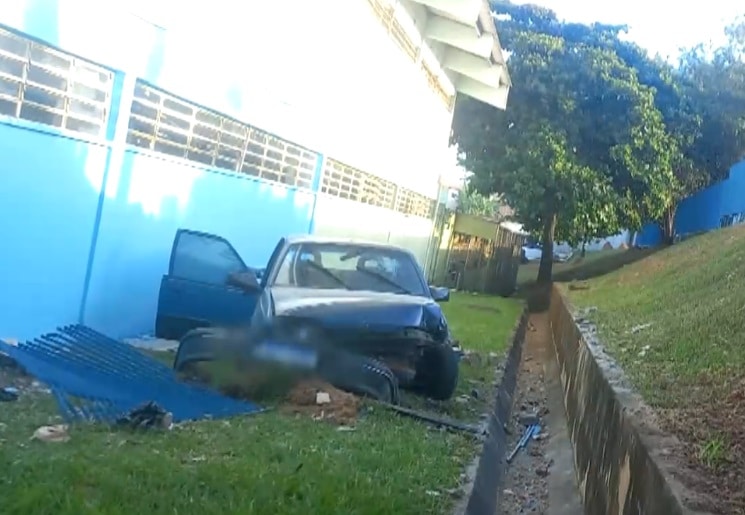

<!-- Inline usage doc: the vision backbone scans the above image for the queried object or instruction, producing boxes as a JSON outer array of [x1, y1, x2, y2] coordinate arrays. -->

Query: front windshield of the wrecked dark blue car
[[272, 242, 429, 296]]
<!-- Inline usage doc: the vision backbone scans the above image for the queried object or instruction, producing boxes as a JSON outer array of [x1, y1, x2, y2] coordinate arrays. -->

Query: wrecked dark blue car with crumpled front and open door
[[156, 229, 459, 401]]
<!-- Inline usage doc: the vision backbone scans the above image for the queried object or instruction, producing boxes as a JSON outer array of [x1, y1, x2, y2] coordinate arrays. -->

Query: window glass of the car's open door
[[170, 232, 247, 285]]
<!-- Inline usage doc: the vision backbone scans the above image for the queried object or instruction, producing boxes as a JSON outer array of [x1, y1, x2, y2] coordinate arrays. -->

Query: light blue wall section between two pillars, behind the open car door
[[84, 151, 314, 336]]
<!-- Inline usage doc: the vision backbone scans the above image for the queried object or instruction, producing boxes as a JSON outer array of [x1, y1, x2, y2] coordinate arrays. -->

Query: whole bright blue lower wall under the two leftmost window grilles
[[0, 120, 321, 338]]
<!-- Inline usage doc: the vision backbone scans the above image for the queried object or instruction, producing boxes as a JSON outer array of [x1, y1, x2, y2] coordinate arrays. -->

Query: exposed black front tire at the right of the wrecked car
[[415, 345, 460, 401]]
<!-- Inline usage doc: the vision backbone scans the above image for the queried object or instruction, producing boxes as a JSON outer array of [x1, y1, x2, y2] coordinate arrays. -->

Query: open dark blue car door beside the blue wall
[[155, 229, 260, 340]]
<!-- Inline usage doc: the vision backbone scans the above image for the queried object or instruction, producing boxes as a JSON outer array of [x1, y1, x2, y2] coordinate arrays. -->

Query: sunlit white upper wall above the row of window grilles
[[0, 0, 454, 197]]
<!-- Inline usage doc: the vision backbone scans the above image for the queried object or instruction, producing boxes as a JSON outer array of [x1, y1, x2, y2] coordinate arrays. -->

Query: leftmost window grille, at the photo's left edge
[[0, 29, 114, 137]]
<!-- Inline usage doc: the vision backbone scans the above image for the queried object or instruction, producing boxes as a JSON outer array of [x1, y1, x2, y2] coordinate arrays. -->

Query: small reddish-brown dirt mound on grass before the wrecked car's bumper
[[280, 380, 359, 426]]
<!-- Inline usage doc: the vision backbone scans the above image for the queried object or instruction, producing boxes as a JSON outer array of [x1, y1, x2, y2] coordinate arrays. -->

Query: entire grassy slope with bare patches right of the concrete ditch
[[564, 226, 745, 513]]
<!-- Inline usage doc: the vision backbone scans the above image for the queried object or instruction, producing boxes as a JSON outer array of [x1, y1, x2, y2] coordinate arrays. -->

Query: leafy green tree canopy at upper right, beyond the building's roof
[[452, 3, 745, 281]]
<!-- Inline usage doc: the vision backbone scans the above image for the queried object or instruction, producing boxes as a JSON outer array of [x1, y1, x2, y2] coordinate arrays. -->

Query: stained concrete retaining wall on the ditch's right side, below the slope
[[549, 287, 707, 515]]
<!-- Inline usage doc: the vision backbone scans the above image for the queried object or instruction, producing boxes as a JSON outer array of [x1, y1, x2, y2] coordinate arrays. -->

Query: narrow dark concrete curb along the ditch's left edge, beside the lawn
[[462, 308, 528, 515]]
